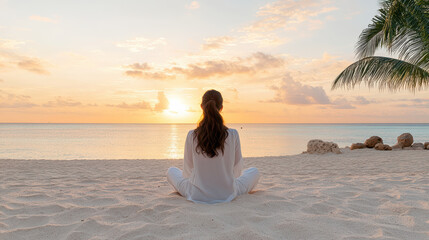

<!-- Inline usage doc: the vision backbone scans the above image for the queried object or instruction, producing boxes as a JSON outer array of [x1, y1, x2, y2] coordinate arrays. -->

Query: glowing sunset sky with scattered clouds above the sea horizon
[[0, 0, 429, 123]]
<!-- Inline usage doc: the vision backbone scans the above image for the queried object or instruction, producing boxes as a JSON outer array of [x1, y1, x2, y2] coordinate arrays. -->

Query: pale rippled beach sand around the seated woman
[[0, 149, 429, 240]]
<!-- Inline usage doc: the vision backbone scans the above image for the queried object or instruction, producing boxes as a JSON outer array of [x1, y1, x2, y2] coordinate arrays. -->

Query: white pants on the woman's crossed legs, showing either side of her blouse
[[167, 167, 260, 197]]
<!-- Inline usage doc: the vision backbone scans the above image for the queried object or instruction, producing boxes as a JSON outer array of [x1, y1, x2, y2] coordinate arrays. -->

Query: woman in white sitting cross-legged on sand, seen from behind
[[167, 90, 259, 203]]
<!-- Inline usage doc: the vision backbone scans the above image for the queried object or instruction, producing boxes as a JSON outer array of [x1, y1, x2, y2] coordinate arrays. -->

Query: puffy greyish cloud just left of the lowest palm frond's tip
[[270, 74, 331, 105]]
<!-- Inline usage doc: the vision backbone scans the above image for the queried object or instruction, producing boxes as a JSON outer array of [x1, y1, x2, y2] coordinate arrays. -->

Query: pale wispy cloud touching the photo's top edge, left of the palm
[[244, 0, 337, 32]]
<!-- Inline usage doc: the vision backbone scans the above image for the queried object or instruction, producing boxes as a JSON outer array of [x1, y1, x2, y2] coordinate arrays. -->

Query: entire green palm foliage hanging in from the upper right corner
[[332, 0, 429, 91]]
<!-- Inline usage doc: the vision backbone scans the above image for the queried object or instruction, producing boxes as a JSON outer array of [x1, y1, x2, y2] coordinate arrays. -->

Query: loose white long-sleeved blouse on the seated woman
[[183, 128, 243, 203]]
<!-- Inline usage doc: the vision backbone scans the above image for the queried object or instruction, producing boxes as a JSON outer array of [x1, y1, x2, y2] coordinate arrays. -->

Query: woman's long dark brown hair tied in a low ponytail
[[194, 90, 228, 158]]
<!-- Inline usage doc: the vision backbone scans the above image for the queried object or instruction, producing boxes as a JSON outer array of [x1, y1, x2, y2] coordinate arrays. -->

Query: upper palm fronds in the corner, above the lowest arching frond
[[356, 0, 429, 61]]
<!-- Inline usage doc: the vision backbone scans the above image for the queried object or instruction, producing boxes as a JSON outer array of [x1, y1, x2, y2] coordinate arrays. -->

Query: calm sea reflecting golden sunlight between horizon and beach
[[0, 124, 429, 160]]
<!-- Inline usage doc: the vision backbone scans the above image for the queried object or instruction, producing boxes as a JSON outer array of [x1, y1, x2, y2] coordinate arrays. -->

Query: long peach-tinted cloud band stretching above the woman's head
[[125, 52, 285, 80]]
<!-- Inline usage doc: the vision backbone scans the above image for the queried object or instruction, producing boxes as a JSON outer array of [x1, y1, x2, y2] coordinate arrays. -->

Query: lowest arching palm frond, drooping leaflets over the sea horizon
[[332, 57, 429, 91]]
